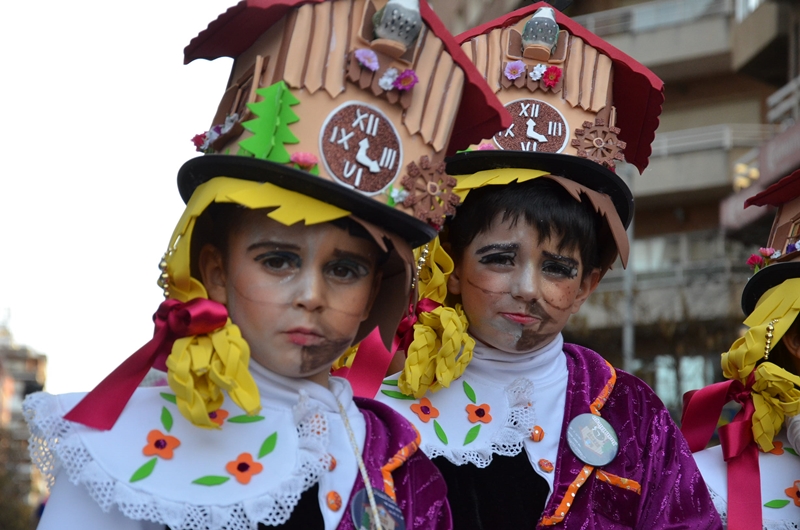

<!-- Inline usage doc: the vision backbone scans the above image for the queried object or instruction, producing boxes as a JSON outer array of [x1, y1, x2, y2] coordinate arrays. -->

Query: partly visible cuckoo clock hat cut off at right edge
[[742, 170, 800, 315]]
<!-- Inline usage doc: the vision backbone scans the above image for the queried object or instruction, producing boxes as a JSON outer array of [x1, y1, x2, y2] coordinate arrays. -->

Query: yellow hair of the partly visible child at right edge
[[722, 278, 800, 451]]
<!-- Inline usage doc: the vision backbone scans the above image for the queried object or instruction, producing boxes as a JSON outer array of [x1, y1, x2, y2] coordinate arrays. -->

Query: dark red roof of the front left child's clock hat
[[183, 0, 511, 154]]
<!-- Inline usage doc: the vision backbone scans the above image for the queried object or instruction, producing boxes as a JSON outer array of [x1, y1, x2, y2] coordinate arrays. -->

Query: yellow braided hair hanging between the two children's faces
[[398, 237, 475, 398]]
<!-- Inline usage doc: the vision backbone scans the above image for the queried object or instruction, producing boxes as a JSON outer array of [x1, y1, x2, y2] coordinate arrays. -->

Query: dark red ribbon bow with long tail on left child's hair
[[64, 298, 228, 431]]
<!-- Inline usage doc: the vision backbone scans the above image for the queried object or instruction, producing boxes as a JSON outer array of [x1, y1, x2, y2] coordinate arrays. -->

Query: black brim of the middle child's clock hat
[[446, 150, 633, 228]]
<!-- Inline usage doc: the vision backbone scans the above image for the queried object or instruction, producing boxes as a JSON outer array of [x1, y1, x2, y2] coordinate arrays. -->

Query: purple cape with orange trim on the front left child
[[338, 398, 453, 530]]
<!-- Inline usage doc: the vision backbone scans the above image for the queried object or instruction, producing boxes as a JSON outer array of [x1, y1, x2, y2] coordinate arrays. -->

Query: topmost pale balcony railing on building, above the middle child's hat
[[574, 0, 733, 37]]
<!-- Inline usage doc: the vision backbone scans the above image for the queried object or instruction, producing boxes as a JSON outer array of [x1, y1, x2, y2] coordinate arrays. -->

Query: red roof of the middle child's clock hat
[[456, 2, 664, 173]]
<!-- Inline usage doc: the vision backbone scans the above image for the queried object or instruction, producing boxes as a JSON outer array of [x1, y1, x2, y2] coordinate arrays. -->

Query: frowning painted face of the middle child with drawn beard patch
[[447, 215, 600, 353]]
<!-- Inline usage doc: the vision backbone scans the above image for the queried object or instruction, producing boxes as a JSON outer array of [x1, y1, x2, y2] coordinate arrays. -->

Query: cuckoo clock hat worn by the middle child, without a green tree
[[447, 2, 664, 264]]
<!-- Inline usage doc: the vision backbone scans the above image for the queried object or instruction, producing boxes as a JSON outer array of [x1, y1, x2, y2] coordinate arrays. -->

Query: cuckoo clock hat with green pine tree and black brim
[[178, 0, 509, 246]]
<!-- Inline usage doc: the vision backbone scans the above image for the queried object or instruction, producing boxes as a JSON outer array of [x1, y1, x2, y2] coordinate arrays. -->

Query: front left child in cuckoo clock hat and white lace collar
[[25, 0, 504, 530]]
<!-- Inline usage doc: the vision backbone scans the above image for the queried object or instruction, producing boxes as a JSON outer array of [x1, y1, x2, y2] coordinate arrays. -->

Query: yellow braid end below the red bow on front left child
[[167, 319, 261, 429]]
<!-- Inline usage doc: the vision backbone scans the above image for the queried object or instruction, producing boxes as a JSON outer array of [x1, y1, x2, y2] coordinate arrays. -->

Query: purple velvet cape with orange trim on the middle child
[[538, 344, 722, 530]]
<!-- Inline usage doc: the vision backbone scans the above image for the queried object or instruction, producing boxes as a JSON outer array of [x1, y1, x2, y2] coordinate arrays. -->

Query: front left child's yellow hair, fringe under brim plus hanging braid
[[165, 177, 350, 429]]
